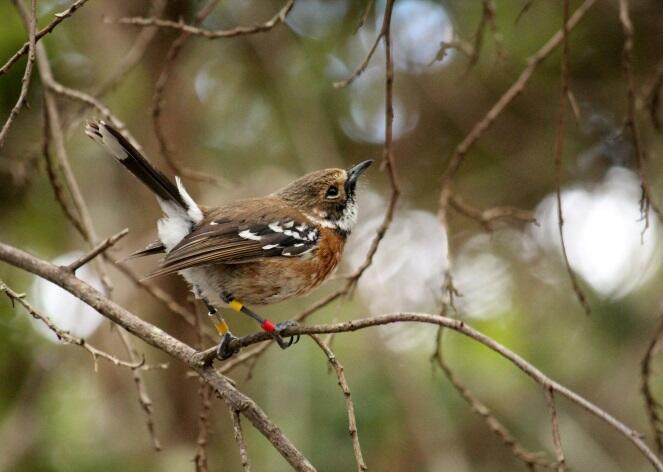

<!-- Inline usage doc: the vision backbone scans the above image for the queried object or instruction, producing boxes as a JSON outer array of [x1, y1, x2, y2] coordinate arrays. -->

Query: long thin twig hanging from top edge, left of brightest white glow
[[554, 0, 591, 315]]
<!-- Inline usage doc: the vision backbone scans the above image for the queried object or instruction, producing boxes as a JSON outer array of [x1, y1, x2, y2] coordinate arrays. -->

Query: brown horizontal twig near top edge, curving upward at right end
[[112, 0, 295, 39]]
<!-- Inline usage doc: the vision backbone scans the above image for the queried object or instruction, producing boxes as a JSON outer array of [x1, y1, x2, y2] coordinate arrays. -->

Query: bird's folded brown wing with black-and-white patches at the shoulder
[[149, 217, 320, 277]]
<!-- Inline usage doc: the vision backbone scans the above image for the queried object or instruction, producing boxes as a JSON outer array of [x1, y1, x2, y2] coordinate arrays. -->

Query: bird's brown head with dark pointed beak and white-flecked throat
[[277, 160, 373, 235]]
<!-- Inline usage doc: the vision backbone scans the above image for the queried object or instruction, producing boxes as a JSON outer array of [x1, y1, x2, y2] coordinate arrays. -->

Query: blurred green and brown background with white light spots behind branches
[[0, 0, 663, 472]]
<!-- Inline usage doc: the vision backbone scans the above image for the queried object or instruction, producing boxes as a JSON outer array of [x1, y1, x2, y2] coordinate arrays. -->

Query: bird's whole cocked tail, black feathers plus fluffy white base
[[85, 121, 203, 255]]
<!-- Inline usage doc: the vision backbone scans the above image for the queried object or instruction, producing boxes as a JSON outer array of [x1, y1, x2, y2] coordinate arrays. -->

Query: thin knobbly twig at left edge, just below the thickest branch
[[0, 280, 168, 371]]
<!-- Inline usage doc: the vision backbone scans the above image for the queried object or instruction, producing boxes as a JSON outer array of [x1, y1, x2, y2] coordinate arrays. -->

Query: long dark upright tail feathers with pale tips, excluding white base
[[85, 121, 189, 211]]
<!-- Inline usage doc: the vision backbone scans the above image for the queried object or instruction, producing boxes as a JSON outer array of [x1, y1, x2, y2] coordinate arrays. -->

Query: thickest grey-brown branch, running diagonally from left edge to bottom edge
[[0, 243, 315, 471]]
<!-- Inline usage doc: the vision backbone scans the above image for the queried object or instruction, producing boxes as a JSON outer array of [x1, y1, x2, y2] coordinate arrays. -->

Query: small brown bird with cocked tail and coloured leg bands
[[85, 120, 373, 360]]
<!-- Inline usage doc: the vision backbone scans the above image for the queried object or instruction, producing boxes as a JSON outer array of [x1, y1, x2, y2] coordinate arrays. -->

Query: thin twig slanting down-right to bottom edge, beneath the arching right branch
[[431, 326, 553, 470]]
